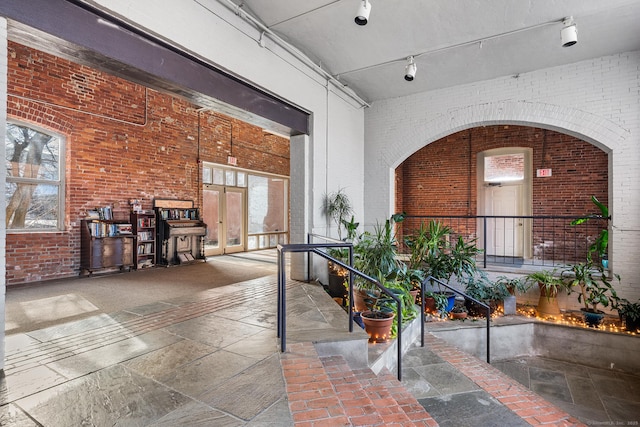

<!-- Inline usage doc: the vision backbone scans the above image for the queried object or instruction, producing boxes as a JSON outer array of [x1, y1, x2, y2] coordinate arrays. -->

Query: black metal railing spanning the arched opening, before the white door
[[399, 215, 608, 268]]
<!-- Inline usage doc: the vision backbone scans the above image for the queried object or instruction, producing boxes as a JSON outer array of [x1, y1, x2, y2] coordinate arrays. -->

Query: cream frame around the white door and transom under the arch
[[476, 147, 533, 259]]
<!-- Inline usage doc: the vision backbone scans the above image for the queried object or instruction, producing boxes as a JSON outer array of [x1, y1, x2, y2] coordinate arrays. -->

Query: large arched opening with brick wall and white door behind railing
[[395, 125, 609, 265]]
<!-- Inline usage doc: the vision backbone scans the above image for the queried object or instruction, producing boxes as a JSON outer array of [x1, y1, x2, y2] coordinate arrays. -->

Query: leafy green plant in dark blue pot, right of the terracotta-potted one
[[563, 259, 620, 328]]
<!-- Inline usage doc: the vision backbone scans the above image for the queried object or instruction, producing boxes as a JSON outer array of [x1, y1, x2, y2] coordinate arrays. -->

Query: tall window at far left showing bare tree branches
[[5, 123, 64, 231]]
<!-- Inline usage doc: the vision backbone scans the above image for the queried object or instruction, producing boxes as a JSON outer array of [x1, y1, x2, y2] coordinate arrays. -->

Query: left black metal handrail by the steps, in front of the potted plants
[[277, 242, 404, 381]]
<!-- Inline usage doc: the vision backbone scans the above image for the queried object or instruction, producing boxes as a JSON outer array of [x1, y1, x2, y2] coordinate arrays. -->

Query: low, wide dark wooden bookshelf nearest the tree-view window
[[80, 219, 135, 274]]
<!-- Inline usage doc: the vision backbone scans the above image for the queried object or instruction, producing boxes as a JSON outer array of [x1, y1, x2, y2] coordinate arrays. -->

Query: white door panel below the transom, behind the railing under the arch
[[484, 184, 524, 257]]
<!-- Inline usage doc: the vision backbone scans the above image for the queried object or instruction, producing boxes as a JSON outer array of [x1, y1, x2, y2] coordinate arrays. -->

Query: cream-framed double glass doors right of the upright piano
[[202, 185, 247, 256]]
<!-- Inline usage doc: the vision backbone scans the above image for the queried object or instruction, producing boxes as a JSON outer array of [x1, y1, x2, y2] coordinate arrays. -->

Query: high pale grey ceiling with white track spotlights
[[232, 0, 640, 101]]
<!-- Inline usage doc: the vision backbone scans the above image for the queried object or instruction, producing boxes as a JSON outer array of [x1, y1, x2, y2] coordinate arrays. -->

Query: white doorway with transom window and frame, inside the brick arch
[[478, 147, 532, 259]]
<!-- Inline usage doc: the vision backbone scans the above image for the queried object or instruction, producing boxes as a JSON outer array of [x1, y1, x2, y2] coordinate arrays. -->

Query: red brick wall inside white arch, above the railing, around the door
[[396, 125, 608, 260]]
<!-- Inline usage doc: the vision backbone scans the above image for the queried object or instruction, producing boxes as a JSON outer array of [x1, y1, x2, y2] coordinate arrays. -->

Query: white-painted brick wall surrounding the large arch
[[364, 51, 640, 299]]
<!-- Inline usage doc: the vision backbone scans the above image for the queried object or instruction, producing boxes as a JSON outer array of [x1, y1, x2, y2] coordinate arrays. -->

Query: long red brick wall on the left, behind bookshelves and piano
[[7, 42, 289, 285]]
